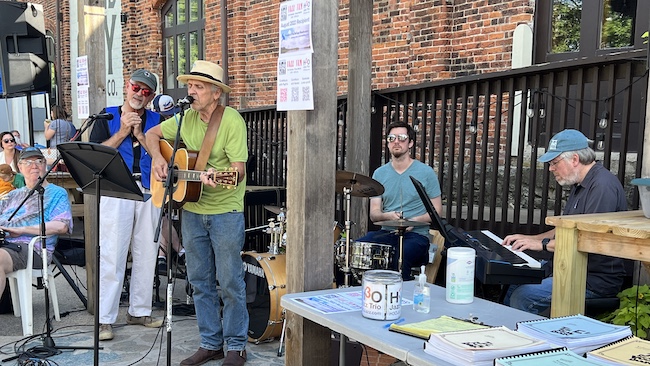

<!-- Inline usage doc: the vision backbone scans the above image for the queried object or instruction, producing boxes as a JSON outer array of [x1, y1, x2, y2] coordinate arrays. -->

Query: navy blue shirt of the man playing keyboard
[[548, 163, 627, 297]]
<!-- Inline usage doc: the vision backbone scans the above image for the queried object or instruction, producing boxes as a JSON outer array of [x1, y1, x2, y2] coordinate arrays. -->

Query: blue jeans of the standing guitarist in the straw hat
[[181, 211, 248, 351]]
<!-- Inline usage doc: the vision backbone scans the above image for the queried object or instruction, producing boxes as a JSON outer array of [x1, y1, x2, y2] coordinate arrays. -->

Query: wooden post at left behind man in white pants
[[81, 0, 106, 313]]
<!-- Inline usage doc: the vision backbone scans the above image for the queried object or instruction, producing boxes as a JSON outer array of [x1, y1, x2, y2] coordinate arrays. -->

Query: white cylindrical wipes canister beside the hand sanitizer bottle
[[445, 247, 476, 304]]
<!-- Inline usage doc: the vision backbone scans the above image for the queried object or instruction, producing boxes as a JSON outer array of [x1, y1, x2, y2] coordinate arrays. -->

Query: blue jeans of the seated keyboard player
[[503, 277, 600, 314]]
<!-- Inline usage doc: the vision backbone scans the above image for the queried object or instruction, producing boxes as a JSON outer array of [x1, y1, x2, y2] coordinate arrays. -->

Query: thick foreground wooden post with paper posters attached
[[285, 0, 339, 366]]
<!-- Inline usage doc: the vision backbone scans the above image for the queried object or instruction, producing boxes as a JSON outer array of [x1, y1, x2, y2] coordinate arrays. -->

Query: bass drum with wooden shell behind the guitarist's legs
[[242, 252, 287, 343]]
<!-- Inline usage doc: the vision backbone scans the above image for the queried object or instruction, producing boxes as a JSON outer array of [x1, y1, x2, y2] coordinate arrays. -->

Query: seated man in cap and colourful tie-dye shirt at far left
[[0, 147, 72, 294]]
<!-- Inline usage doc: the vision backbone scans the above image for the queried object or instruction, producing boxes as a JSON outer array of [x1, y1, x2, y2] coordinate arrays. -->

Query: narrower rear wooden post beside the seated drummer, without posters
[[345, 0, 370, 238]]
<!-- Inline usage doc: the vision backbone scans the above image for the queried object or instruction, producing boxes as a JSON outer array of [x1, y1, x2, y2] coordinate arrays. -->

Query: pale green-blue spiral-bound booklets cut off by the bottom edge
[[494, 348, 606, 366]]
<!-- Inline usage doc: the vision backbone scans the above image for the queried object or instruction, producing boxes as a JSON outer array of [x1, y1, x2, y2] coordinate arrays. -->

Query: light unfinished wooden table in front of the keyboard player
[[546, 211, 650, 318]]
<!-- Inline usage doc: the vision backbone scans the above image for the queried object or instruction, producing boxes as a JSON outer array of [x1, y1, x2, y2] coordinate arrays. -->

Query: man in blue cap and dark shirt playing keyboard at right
[[503, 129, 627, 315]]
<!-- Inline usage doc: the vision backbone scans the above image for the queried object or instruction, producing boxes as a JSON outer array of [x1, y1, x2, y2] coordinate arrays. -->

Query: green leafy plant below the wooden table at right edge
[[601, 285, 650, 338]]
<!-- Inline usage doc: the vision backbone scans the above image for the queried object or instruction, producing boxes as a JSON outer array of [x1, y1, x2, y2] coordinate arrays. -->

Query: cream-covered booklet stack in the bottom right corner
[[587, 337, 650, 366]]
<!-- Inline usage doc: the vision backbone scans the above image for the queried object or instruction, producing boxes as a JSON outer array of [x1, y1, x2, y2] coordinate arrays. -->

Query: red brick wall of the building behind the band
[[35, 0, 535, 108]]
